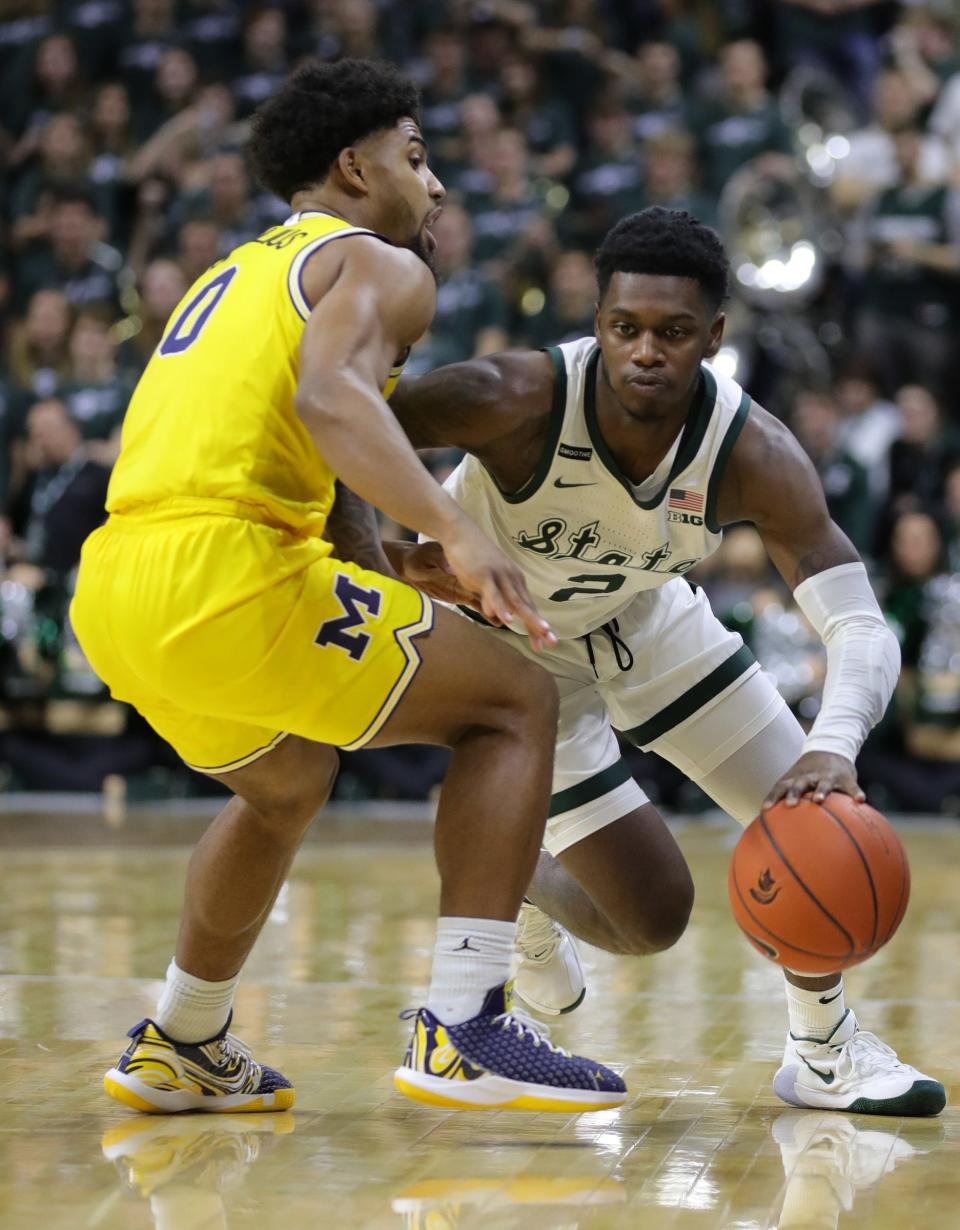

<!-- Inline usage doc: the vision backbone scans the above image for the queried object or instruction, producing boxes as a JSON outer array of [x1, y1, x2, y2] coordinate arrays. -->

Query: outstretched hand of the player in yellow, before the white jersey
[[443, 518, 556, 651]]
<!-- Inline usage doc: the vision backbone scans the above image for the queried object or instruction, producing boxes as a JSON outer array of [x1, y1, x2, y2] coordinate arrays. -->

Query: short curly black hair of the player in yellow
[[247, 59, 420, 200]]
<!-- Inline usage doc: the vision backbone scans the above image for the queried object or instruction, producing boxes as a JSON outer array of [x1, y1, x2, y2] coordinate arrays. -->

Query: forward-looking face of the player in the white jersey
[[596, 273, 724, 421]]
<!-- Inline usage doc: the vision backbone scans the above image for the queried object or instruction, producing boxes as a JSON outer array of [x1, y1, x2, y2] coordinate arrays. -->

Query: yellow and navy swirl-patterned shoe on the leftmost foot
[[103, 1017, 295, 1114]]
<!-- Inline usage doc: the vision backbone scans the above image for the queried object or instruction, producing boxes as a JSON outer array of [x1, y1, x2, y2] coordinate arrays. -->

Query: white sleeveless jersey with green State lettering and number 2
[[444, 337, 751, 640]]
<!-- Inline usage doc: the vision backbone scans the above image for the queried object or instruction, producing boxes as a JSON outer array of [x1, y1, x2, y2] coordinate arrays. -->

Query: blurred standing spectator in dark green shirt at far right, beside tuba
[[858, 128, 960, 395]]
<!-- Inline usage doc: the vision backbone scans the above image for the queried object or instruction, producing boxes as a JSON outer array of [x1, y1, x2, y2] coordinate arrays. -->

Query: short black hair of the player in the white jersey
[[593, 205, 730, 311]]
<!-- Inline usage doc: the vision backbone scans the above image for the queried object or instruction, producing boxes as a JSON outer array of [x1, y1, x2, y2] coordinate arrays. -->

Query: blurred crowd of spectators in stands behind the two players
[[0, 0, 960, 814]]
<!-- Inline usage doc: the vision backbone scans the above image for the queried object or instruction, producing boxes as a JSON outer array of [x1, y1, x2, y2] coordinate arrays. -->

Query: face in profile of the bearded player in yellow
[[370, 118, 446, 268]]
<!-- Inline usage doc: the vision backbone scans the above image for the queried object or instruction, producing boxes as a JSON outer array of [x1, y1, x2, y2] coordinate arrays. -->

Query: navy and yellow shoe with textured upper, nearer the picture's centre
[[394, 986, 626, 1114]]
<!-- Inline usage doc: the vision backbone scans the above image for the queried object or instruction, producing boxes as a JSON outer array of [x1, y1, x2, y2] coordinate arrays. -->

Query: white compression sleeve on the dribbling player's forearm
[[794, 562, 900, 760]]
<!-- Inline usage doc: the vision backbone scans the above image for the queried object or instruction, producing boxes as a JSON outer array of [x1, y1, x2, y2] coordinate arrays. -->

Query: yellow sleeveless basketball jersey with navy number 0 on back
[[107, 212, 402, 535]]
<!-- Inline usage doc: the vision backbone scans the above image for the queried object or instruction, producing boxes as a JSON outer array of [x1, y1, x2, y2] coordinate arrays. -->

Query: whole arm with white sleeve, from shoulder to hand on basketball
[[718, 406, 900, 807]]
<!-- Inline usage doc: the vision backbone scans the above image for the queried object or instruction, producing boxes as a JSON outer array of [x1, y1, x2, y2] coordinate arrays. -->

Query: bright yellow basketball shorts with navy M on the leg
[[70, 514, 433, 772]]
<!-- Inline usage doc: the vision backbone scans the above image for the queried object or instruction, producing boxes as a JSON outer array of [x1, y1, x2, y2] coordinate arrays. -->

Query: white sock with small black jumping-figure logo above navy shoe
[[427, 919, 517, 1025]]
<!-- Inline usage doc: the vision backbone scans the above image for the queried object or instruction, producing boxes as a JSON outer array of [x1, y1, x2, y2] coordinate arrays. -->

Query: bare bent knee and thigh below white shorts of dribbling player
[[558, 803, 694, 953]]
